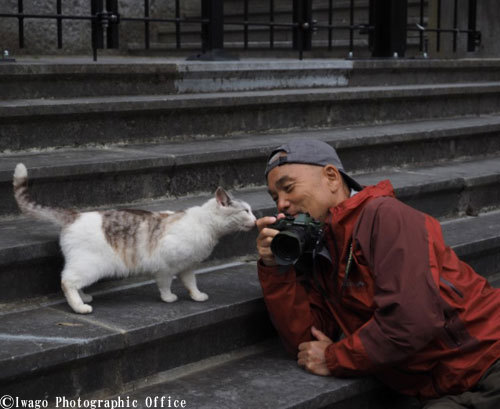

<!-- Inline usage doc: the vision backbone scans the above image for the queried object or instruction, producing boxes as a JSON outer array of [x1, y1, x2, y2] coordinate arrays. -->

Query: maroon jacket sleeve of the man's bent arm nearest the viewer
[[325, 197, 444, 376]]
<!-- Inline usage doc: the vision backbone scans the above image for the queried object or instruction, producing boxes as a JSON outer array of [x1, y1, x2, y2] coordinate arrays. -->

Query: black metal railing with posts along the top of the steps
[[0, 0, 481, 61]]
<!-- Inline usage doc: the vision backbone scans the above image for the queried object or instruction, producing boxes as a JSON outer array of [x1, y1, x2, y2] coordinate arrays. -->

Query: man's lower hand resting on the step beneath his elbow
[[297, 327, 333, 376]]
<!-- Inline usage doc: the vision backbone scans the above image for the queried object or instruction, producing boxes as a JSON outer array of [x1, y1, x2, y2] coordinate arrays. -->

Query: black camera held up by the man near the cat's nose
[[268, 213, 323, 266]]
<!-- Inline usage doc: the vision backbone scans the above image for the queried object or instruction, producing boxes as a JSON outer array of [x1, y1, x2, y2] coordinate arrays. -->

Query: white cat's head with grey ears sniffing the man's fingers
[[211, 187, 256, 231]]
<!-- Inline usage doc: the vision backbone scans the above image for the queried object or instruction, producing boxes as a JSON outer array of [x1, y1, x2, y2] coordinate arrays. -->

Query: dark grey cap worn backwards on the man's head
[[266, 139, 363, 191]]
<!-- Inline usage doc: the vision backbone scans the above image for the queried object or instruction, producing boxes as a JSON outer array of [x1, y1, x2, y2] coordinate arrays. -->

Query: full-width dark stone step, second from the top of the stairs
[[0, 82, 500, 151]]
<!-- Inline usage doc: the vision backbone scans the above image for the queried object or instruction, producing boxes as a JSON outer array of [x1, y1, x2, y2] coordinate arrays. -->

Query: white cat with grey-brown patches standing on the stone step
[[13, 163, 256, 314]]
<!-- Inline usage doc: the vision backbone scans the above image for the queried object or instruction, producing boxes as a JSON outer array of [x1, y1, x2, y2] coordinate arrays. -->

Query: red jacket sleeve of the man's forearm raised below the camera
[[258, 261, 339, 356]]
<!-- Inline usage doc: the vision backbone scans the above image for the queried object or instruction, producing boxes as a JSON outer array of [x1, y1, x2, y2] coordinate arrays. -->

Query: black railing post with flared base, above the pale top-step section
[[187, 0, 238, 61]]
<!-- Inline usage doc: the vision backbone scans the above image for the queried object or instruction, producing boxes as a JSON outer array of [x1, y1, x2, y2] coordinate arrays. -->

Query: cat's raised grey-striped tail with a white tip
[[14, 163, 78, 226]]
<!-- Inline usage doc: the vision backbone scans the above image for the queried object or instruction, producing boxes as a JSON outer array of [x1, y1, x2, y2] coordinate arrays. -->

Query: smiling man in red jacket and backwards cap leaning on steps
[[257, 139, 500, 409]]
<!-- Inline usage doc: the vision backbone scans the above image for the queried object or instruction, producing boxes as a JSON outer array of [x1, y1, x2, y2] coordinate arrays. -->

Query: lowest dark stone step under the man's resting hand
[[113, 346, 421, 409]]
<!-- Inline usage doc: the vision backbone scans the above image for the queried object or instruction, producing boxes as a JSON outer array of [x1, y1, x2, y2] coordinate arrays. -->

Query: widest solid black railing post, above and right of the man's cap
[[370, 0, 408, 58]]
